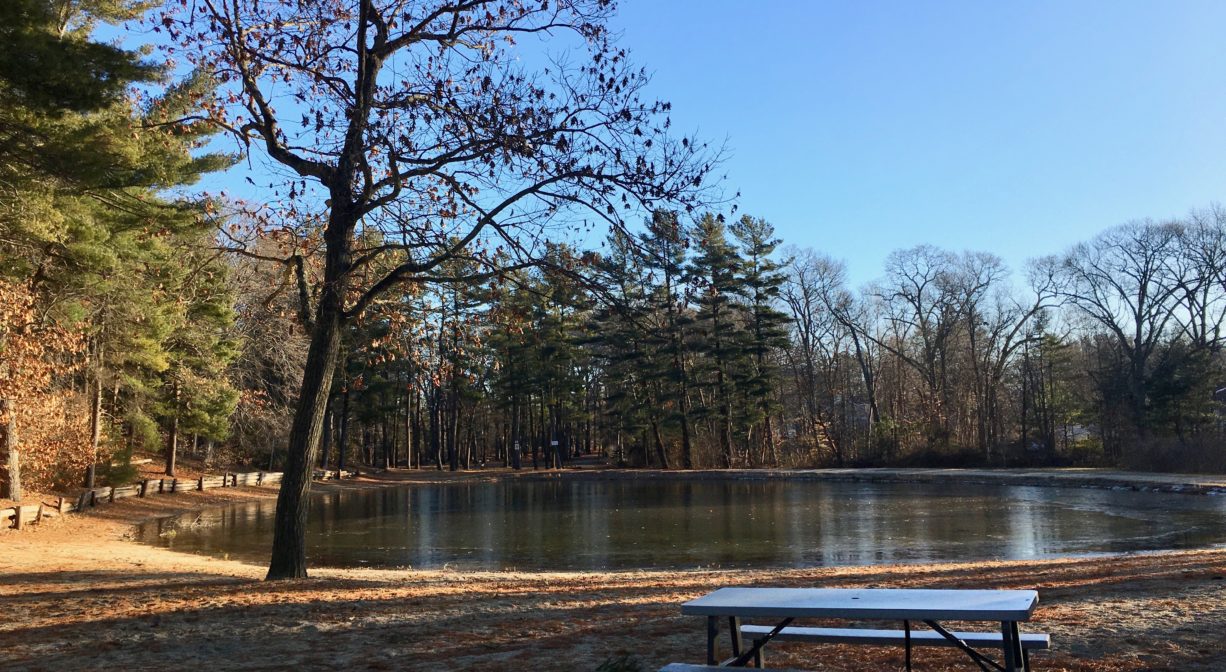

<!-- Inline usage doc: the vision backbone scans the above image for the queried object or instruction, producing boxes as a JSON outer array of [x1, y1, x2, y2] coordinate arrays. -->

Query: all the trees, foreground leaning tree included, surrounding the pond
[[0, 0, 1226, 575]]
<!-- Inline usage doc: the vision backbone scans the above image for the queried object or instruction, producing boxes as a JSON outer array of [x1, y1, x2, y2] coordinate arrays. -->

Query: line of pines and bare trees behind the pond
[[289, 207, 1226, 471]]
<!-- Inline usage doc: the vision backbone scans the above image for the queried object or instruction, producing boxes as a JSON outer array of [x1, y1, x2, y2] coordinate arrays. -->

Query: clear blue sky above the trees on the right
[[614, 0, 1226, 283]]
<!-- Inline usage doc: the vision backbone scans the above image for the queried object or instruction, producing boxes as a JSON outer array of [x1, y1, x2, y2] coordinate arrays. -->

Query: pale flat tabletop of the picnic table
[[682, 587, 1038, 620]]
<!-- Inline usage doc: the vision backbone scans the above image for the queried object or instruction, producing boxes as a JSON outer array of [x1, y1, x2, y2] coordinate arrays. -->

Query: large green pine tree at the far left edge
[[0, 0, 229, 492]]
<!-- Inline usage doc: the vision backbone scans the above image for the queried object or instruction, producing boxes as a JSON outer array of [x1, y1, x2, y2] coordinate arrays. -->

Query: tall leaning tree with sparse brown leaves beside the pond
[[167, 0, 710, 579]]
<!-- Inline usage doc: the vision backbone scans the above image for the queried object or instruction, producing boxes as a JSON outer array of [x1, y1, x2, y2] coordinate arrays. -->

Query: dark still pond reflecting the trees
[[131, 478, 1226, 570]]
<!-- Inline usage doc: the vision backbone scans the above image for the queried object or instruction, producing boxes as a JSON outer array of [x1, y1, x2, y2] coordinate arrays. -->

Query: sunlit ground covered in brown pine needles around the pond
[[0, 472, 1226, 672]]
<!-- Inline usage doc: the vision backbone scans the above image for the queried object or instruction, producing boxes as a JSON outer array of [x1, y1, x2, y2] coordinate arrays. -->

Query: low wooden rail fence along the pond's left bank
[[0, 471, 284, 530]]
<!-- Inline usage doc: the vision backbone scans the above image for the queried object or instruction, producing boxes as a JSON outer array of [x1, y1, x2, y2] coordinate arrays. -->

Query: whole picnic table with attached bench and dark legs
[[682, 587, 1047, 672]]
